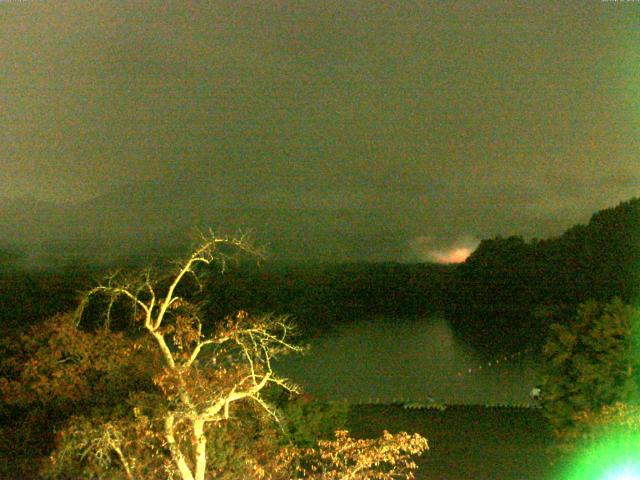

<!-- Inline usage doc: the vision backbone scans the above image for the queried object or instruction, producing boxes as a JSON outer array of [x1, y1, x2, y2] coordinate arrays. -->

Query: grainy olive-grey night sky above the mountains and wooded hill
[[0, 0, 640, 262]]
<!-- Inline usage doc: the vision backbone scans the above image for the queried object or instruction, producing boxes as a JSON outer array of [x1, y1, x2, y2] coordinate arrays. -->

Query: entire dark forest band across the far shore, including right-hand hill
[[0, 198, 640, 350]]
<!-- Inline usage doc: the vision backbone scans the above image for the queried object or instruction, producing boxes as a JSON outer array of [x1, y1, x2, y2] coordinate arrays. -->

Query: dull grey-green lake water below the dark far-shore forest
[[276, 317, 539, 404]]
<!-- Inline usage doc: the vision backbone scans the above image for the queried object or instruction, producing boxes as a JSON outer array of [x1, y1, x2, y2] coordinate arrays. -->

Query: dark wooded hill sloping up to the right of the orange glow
[[445, 198, 640, 353]]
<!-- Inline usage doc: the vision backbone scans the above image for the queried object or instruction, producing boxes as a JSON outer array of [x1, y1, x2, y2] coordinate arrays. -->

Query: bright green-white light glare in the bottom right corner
[[559, 432, 640, 480]]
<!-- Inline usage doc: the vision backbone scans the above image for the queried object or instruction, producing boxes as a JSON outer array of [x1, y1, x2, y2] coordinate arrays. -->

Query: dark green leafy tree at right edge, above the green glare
[[542, 299, 640, 435]]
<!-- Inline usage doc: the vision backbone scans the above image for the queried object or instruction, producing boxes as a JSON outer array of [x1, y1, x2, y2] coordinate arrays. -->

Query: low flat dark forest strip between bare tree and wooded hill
[[196, 263, 453, 336]]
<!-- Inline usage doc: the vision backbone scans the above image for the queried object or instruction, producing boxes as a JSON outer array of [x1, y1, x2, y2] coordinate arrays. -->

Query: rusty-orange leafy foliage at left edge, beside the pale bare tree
[[0, 314, 153, 404]]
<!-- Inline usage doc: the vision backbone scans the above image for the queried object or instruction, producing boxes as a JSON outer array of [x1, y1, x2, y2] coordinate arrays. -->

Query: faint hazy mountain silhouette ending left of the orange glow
[[0, 177, 403, 261]]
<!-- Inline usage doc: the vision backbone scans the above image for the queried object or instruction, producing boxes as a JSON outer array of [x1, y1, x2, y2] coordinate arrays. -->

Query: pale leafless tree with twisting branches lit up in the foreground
[[76, 235, 301, 480]]
